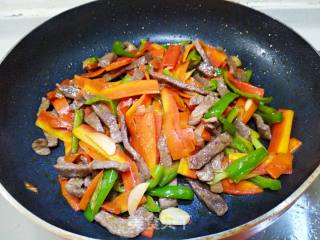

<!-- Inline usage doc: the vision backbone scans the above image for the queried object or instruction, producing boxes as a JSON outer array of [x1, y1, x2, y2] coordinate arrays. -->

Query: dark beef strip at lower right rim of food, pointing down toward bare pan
[[187, 178, 228, 216]]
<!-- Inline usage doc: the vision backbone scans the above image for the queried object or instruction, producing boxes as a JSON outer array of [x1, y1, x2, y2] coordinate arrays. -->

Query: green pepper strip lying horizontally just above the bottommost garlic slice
[[148, 186, 194, 200]]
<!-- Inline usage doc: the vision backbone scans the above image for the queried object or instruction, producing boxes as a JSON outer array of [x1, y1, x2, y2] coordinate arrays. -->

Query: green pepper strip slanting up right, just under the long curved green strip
[[204, 92, 239, 119]]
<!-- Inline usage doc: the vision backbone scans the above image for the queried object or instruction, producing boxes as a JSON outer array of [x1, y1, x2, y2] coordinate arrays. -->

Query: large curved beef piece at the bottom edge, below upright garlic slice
[[94, 207, 153, 238]]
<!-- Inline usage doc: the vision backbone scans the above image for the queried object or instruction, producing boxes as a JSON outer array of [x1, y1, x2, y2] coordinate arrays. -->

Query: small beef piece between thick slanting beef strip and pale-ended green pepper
[[196, 153, 224, 182]]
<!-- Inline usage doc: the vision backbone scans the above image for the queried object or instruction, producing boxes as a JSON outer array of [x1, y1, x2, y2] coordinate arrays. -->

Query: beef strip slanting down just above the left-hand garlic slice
[[92, 103, 122, 143]]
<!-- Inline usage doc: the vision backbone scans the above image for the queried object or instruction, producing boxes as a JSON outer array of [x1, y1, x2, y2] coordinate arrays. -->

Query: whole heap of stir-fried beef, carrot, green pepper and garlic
[[32, 39, 302, 238]]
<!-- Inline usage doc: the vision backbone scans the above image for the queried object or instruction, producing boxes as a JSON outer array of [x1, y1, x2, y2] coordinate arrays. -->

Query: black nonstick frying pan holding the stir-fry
[[0, 0, 320, 239]]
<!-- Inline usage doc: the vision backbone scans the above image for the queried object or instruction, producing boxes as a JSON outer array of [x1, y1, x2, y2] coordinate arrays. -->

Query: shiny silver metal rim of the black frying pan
[[0, 0, 320, 240]]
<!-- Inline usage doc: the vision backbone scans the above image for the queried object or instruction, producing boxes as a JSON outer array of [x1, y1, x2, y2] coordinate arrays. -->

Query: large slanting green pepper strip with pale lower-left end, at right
[[209, 148, 268, 184]]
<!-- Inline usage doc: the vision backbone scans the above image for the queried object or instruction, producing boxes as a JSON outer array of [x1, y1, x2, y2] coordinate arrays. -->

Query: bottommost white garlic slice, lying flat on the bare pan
[[159, 207, 190, 225]]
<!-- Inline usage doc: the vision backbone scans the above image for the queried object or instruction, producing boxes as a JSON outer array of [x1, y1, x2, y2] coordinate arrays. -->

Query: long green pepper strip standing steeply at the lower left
[[84, 169, 118, 222]]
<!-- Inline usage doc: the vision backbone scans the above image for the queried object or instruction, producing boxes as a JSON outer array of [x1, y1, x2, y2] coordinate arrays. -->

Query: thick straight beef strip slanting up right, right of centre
[[188, 133, 231, 169]]
